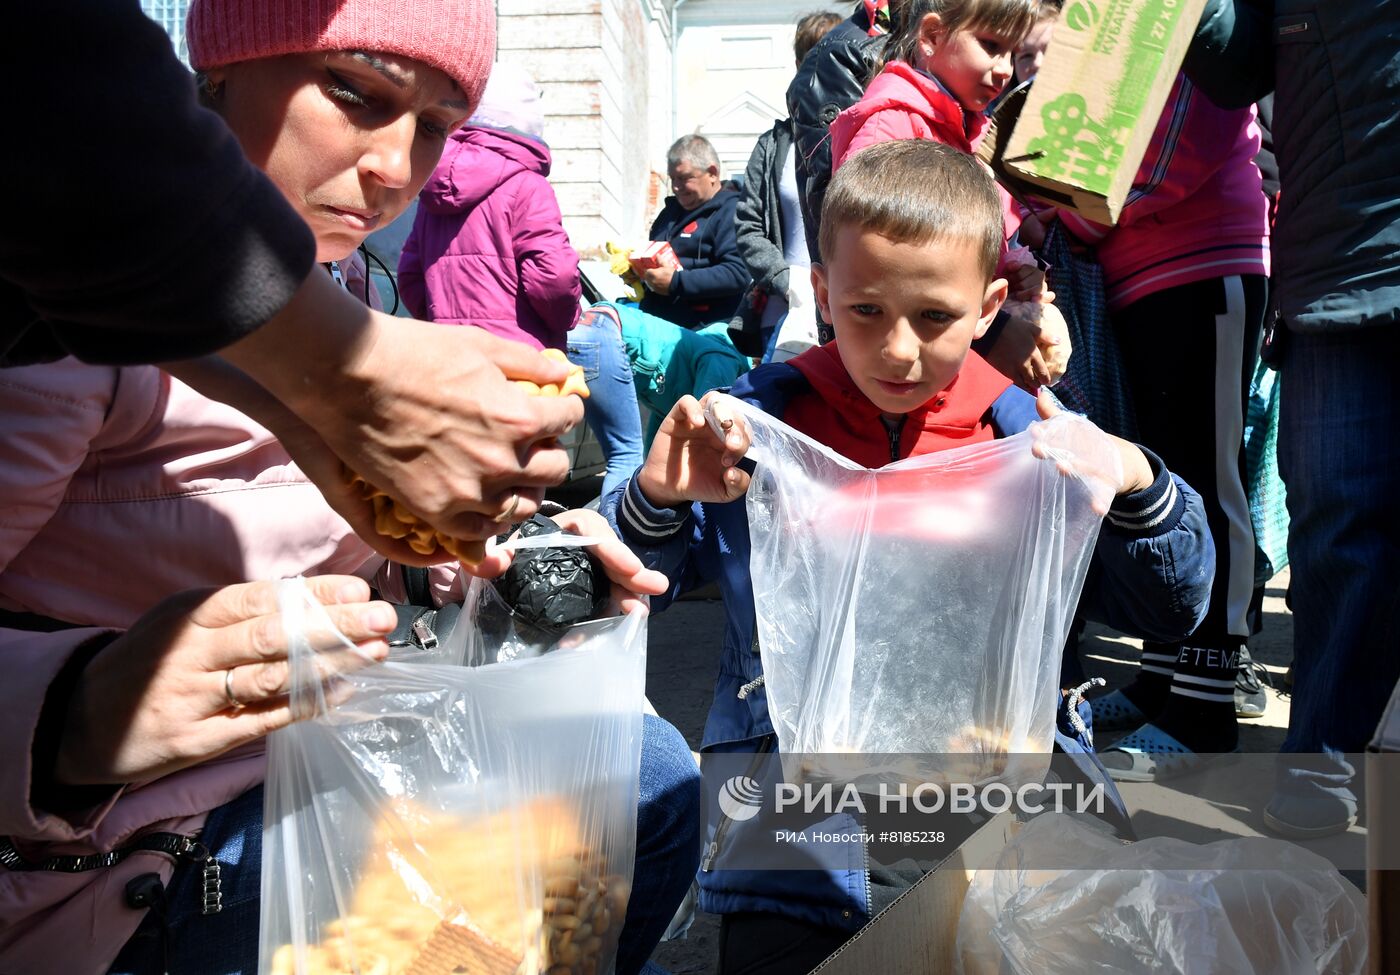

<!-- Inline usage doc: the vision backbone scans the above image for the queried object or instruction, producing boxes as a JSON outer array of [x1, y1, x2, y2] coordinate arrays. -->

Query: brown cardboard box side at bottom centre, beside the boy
[[812, 813, 1016, 975]]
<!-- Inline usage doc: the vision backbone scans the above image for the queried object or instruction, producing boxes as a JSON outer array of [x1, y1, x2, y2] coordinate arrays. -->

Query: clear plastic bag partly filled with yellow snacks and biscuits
[[259, 580, 645, 975]]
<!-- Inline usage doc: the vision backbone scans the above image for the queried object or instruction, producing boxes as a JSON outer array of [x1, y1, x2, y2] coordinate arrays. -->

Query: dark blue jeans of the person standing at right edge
[[1278, 324, 1400, 798]]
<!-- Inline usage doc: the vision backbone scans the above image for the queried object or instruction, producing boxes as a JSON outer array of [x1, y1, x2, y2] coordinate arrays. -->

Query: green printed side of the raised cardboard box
[[1021, 0, 1187, 195]]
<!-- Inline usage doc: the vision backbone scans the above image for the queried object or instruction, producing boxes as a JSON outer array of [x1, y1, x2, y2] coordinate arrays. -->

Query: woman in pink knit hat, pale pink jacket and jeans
[[0, 0, 699, 975]]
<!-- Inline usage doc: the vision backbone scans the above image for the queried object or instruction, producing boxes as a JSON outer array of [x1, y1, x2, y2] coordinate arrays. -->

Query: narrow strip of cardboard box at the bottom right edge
[[1366, 686, 1400, 975]]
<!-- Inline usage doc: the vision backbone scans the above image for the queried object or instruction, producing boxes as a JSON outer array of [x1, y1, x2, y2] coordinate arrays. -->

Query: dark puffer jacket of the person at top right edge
[[1186, 0, 1400, 332]]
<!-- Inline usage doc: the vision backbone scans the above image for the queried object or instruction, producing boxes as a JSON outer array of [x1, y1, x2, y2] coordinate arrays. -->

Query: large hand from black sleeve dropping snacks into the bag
[[217, 274, 584, 565]]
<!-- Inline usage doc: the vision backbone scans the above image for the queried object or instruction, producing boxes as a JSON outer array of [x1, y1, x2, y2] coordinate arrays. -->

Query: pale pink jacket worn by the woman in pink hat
[[0, 257, 445, 975]]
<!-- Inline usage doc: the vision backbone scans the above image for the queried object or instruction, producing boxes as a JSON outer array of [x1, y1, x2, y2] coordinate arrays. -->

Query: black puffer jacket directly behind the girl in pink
[[788, 6, 886, 262]]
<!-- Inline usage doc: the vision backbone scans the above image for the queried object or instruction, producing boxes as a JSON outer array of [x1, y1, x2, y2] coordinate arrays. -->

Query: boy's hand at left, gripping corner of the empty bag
[[637, 392, 750, 507]]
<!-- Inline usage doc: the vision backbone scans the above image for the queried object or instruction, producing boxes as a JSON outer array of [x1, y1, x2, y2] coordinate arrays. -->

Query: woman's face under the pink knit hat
[[207, 50, 470, 261]]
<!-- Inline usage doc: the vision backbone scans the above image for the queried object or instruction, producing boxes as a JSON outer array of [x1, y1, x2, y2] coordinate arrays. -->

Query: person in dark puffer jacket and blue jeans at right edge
[[1186, 0, 1400, 839]]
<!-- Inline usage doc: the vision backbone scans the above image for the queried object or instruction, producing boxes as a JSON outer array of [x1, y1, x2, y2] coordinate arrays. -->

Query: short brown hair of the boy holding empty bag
[[818, 139, 1005, 282]]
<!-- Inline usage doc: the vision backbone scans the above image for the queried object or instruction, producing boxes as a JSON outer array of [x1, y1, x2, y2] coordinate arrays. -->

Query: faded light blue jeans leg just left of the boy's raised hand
[[567, 311, 643, 497]]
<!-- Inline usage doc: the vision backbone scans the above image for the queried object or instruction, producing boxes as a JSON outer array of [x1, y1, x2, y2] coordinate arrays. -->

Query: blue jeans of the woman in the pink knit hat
[[111, 714, 700, 975]]
